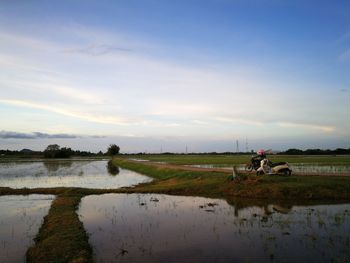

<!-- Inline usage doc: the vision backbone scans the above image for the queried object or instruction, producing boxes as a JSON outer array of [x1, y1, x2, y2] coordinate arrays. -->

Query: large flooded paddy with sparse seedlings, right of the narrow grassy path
[[78, 194, 350, 263]]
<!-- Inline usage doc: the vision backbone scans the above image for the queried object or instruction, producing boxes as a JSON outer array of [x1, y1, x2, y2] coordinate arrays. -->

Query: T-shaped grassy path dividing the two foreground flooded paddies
[[0, 187, 118, 263]]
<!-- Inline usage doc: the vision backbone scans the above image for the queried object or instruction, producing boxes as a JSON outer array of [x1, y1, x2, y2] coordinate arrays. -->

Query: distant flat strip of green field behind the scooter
[[125, 154, 350, 165]]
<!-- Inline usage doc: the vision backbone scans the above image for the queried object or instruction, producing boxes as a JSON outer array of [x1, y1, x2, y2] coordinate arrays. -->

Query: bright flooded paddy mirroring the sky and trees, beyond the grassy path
[[0, 161, 151, 188]]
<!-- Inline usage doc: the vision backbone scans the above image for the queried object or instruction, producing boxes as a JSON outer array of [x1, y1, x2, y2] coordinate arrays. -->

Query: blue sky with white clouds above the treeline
[[0, 0, 350, 152]]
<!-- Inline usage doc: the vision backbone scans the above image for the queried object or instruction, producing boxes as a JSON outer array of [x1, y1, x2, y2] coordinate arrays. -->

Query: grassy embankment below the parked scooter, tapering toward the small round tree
[[113, 158, 350, 201]]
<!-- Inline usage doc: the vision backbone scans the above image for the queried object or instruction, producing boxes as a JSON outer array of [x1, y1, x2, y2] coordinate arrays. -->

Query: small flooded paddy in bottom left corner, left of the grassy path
[[0, 195, 54, 262]]
